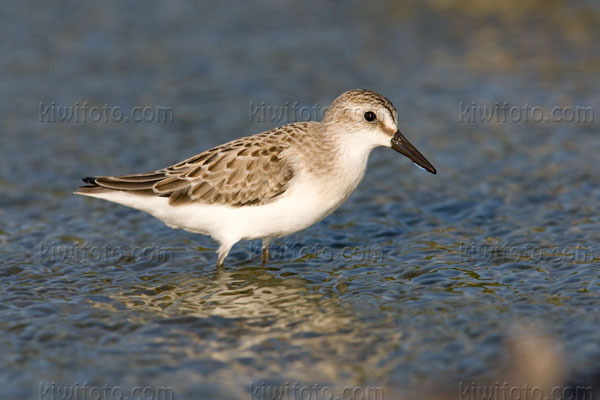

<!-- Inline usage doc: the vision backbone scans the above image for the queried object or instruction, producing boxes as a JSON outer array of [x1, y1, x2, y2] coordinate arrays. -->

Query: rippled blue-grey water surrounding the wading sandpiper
[[0, 0, 600, 399]]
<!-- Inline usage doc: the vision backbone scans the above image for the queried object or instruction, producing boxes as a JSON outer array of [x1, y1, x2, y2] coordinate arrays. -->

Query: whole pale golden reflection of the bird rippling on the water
[[88, 262, 390, 385]]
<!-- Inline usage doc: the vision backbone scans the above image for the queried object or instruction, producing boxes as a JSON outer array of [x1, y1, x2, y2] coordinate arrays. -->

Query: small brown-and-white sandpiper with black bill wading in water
[[75, 90, 436, 266]]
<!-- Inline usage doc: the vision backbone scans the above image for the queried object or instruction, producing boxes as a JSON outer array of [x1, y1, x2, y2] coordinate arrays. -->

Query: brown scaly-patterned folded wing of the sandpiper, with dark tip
[[80, 129, 294, 207]]
